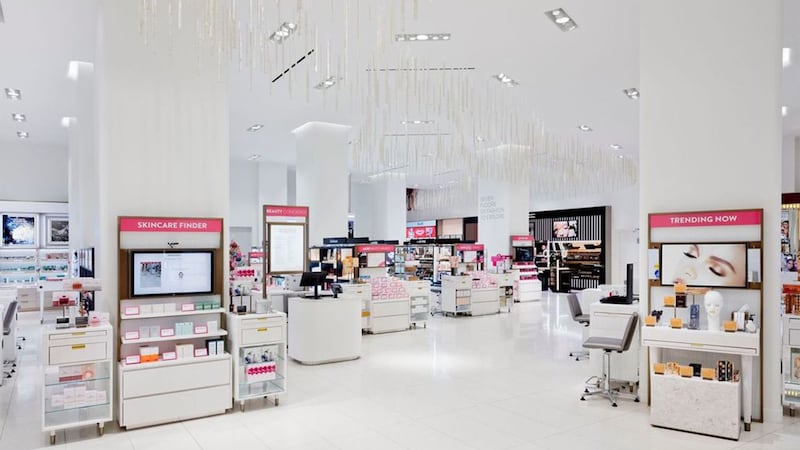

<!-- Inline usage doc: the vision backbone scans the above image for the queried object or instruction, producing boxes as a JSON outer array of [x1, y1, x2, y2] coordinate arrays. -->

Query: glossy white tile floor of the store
[[0, 294, 800, 450]]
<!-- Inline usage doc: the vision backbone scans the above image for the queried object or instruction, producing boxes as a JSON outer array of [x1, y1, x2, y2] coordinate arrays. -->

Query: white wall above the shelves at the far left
[[0, 142, 68, 202]]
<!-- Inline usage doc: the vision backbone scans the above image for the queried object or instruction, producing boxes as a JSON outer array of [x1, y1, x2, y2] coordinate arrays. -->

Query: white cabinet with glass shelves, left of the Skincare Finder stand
[[42, 324, 114, 444]]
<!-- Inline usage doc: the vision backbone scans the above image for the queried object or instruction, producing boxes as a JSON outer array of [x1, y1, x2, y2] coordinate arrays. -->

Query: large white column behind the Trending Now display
[[639, 0, 781, 421]]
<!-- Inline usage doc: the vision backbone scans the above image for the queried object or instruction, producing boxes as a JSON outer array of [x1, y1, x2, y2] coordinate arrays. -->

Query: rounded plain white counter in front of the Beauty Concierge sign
[[289, 295, 361, 364]]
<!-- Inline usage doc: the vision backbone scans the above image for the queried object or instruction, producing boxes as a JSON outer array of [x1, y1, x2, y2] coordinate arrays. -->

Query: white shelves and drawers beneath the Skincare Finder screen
[[117, 295, 232, 429]]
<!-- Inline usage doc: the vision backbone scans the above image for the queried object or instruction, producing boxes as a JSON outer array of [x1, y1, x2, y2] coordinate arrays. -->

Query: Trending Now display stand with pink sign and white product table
[[640, 209, 763, 439]]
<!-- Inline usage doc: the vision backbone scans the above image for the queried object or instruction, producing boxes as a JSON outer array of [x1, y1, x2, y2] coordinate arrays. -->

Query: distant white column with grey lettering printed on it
[[478, 179, 530, 260]]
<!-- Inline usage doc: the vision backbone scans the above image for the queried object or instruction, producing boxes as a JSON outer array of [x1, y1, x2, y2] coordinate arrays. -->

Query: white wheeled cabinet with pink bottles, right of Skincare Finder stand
[[227, 312, 287, 411]]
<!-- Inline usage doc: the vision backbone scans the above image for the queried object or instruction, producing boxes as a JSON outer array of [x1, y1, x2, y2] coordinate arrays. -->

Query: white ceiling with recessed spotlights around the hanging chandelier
[[0, 0, 800, 189]]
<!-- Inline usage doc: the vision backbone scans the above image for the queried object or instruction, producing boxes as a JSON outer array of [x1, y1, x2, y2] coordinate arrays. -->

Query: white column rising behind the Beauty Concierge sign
[[292, 122, 350, 245]]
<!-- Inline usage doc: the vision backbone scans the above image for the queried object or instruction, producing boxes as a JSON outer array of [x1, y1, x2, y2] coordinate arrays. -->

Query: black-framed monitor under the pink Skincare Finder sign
[[130, 250, 214, 297]]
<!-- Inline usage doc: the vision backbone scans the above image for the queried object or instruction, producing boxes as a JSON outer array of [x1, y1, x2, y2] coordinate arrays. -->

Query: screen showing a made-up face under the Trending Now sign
[[660, 242, 747, 288]]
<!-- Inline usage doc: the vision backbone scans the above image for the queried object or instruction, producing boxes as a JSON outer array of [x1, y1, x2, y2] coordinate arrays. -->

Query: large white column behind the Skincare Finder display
[[95, 0, 230, 316]]
